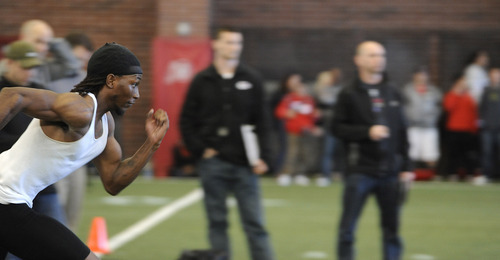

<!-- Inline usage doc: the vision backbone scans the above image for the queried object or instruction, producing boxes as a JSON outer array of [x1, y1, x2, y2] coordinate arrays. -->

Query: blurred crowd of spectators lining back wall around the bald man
[[270, 51, 500, 186]]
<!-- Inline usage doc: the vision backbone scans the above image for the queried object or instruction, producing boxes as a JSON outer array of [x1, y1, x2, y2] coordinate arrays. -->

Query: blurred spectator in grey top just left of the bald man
[[314, 68, 342, 187]]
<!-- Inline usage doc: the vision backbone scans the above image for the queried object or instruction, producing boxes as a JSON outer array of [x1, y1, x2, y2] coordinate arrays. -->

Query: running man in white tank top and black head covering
[[0, 43, 169, 259]]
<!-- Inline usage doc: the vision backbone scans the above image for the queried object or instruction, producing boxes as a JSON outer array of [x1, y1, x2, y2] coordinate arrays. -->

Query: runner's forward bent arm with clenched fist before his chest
[[93, 109, 169, 195]]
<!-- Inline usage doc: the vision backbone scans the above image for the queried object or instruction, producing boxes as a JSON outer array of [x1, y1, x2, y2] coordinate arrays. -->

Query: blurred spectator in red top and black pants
[[442, 75, 479, 181]]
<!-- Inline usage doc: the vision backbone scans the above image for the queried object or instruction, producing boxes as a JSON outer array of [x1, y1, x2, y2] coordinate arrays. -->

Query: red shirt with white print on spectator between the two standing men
[[274, 92, 316, 134]]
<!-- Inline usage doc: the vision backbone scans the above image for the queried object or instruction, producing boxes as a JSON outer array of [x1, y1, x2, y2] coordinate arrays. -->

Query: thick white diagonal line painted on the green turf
[[101, 188, 203, 254]]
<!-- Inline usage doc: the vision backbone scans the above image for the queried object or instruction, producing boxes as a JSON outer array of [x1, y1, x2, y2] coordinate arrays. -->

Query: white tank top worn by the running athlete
[[0, 93, 108, 207]]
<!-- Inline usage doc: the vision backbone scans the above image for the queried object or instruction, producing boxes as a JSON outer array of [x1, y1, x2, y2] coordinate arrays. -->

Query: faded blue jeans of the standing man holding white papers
[[198, 157, 274, 260]]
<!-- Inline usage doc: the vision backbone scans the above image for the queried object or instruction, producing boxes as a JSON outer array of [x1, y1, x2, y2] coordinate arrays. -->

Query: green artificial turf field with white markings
[[78, 178, 500, 260]]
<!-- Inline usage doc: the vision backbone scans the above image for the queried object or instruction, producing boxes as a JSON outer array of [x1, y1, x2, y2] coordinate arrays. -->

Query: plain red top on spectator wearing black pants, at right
[[443, 91, 479, 133]]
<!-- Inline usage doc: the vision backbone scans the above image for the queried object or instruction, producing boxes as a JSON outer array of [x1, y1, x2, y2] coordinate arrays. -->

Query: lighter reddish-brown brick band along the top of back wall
[[214, 0, 500, 30]]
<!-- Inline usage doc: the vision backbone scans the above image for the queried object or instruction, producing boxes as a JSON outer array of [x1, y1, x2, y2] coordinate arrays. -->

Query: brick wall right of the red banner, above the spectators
[[212, 0, 500, 88]]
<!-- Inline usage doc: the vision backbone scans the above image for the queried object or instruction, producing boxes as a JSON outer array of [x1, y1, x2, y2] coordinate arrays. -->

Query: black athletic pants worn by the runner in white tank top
[[0, 204, 90, 260]]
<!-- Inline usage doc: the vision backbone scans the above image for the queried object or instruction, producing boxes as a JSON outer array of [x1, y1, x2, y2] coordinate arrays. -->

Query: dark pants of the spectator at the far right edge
[[481, 130, 500, 178]]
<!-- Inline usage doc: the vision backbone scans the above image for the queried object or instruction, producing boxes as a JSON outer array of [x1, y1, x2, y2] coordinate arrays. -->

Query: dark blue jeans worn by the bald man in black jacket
[[337, 174, 403, 260]]
